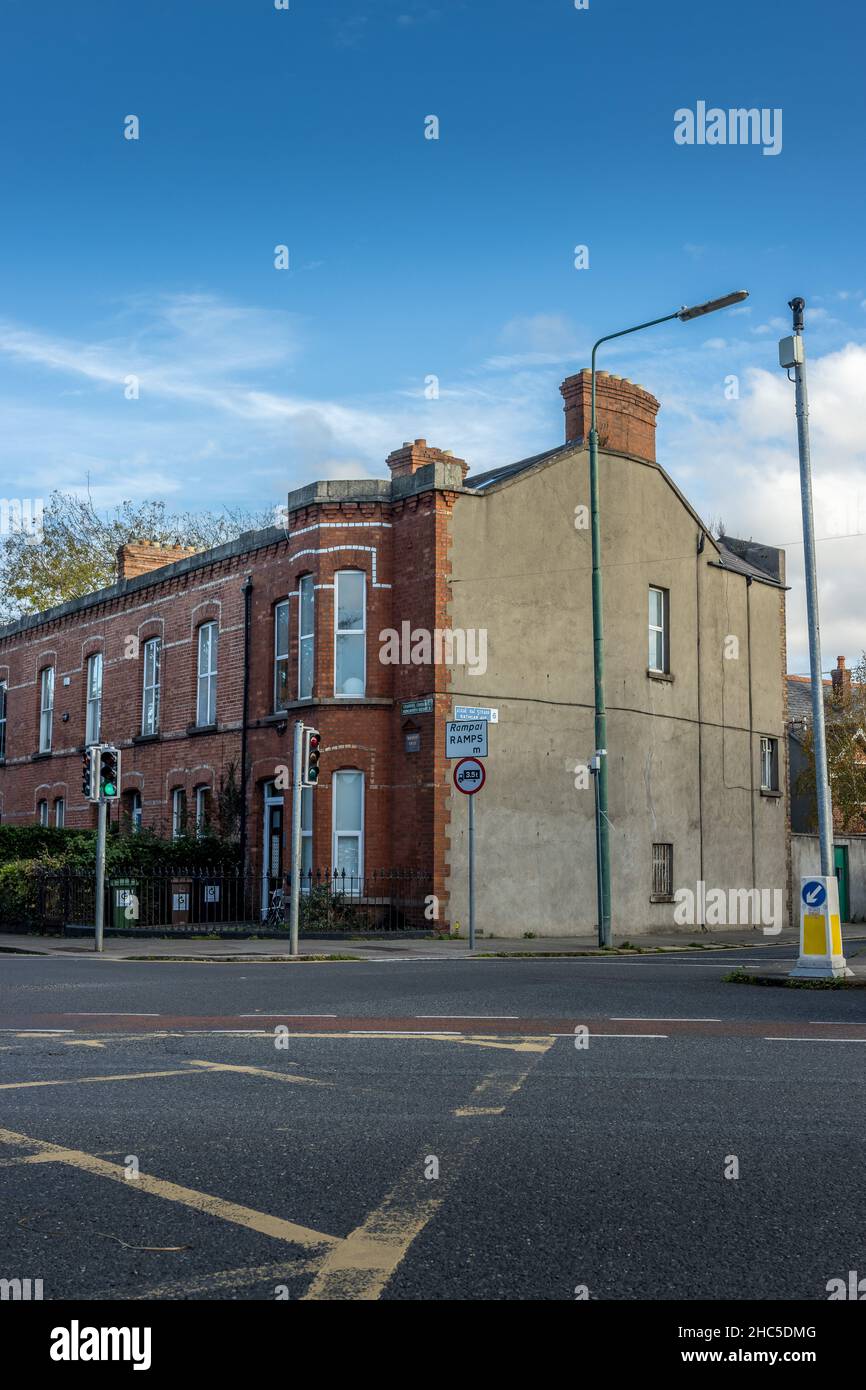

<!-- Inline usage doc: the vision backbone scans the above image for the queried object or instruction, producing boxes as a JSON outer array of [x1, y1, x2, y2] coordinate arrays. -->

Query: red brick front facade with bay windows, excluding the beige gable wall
[[0, 439, 467, 911]]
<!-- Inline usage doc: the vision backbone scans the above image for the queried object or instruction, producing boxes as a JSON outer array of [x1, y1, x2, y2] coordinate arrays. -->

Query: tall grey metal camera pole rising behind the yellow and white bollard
[[788, 299, 835, 877]]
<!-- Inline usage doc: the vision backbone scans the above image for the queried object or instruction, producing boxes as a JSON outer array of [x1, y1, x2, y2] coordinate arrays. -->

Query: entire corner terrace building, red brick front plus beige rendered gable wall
[[0, 371, 790, 935]]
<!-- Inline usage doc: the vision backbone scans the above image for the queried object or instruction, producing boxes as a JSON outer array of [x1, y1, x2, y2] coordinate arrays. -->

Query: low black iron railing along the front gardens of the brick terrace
[[0, 866, 436, 935]]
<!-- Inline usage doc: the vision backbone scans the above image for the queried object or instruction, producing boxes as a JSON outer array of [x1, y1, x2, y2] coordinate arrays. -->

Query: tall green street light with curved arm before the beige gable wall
[[589, 289, 749, 947]]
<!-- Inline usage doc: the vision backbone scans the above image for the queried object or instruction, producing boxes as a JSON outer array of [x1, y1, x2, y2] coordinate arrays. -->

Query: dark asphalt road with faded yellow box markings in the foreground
[[0, 948, 866, 1300]]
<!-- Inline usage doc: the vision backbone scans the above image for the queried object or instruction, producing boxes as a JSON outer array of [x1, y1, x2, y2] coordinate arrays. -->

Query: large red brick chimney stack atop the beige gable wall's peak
[[559, 367, 659, 463]]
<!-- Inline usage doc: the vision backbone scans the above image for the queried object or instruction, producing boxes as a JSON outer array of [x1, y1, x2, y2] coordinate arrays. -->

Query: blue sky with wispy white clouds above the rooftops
[[0, 0, 866, 670]]
